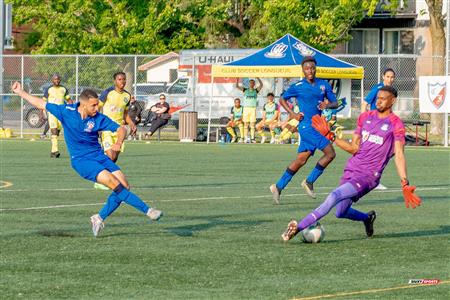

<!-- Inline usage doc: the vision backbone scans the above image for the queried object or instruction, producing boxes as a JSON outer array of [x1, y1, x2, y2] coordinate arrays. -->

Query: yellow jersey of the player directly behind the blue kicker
[[100, 86, 131, 125]]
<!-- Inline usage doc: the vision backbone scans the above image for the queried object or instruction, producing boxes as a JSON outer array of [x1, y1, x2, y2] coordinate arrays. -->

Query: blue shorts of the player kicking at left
[[71, 153, 120, 182]]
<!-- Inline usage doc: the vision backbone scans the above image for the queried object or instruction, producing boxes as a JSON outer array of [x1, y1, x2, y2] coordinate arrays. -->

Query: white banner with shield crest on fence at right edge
[[419, 76, 450, 113]]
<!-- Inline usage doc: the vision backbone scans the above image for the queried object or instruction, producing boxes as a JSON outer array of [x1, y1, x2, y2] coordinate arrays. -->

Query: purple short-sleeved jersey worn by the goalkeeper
[[342, 110, 405, 181]]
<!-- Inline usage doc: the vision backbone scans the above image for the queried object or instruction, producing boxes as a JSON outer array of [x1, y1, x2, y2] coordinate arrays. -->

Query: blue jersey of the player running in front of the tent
[[281, 78, 336, 128]]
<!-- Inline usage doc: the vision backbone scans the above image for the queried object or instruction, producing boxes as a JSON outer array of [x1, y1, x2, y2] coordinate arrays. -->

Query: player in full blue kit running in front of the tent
[[270, 56, 338, 204]]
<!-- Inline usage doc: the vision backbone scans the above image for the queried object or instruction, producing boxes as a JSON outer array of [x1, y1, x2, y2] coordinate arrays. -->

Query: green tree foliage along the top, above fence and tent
[[9, 0, 398, 54]]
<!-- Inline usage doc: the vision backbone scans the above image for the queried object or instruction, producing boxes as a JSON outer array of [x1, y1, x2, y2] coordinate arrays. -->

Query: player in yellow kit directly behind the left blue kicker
[[99, 72, 136, 162]]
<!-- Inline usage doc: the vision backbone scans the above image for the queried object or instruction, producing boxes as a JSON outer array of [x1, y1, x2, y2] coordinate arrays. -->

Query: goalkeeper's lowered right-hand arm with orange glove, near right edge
[[394, 141, 422, 209]]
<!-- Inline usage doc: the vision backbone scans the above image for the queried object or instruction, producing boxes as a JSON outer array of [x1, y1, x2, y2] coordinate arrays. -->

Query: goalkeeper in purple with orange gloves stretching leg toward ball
[[281, 86, 422, 242]]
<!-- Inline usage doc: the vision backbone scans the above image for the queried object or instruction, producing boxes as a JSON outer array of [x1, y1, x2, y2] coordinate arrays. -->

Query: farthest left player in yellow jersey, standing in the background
[[44, 74, 72, 158]]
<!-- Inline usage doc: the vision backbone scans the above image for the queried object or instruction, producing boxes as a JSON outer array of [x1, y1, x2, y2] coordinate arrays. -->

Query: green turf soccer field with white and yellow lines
[[0, 140, 450, 299]]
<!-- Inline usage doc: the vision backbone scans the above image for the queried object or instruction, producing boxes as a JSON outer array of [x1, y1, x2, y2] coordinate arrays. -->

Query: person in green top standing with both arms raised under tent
[[236, 78, 263, 143]]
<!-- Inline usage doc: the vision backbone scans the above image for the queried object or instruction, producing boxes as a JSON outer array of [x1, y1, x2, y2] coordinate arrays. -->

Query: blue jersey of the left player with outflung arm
[[45, 103, 120, 159]]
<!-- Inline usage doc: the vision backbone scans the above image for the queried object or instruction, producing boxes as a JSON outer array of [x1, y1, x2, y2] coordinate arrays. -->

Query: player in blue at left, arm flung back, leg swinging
[[12, 82, 163, 236]]
